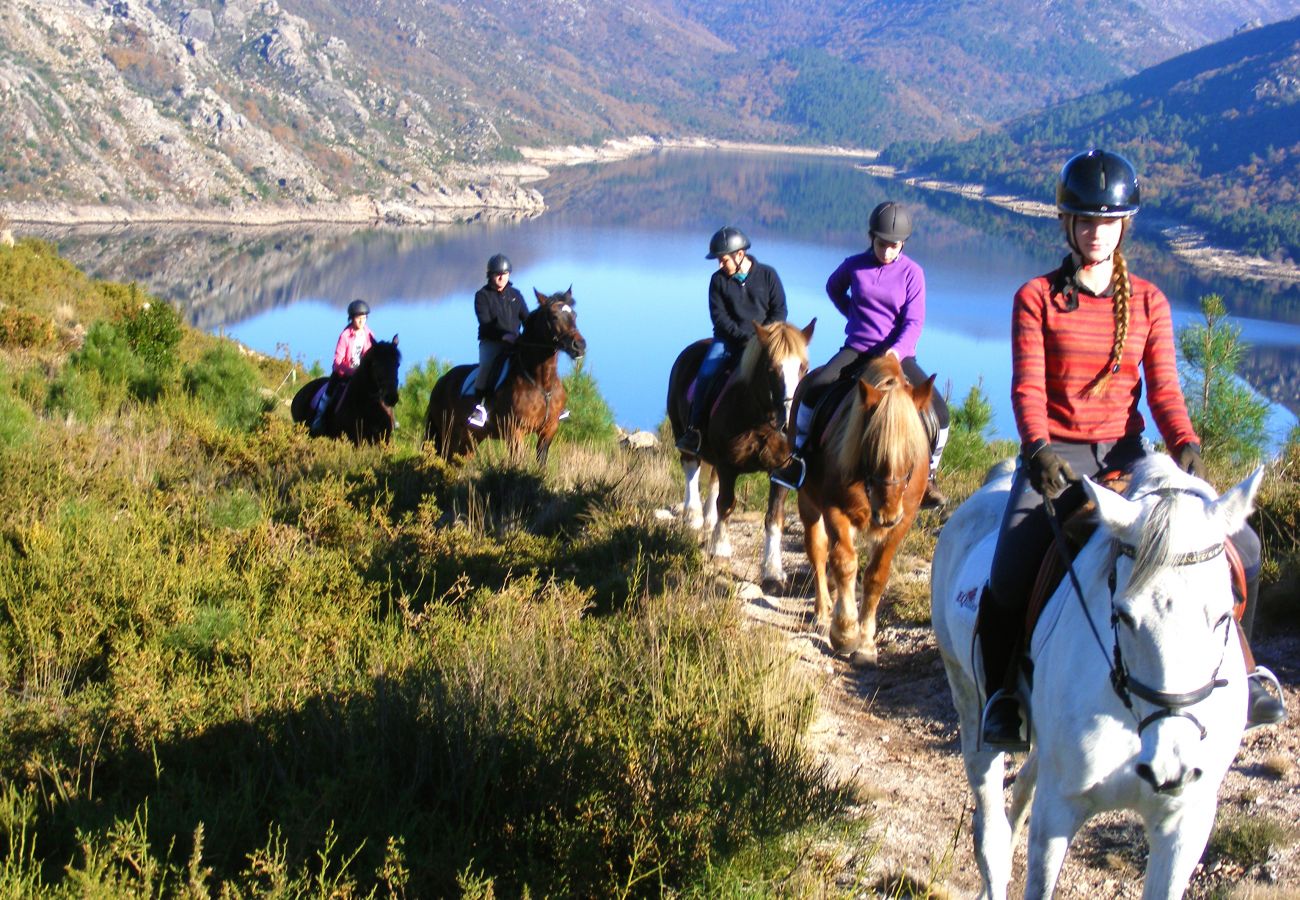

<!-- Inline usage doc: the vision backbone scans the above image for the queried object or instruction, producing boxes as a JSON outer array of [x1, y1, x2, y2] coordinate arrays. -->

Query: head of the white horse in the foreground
[[1084, 454, 1264, 796]]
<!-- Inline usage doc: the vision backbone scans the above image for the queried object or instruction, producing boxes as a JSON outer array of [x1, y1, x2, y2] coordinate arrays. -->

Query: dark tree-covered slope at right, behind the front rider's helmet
[[881, 17, 1300, 260]]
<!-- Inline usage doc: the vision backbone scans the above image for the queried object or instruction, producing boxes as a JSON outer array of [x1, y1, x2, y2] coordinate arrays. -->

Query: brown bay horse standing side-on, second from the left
[[424, 287, 586, 463]]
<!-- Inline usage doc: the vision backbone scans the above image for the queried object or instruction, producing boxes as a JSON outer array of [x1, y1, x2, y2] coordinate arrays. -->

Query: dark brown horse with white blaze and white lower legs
[[668, 319, 816, 585]]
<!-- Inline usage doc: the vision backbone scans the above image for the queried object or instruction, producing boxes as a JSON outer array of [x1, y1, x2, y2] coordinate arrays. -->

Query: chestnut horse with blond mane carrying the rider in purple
[[796, 354, 935, 666]]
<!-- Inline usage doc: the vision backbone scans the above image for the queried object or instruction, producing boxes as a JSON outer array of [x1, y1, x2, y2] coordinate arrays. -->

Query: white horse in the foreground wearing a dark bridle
[[931, 455, 1264, 900]]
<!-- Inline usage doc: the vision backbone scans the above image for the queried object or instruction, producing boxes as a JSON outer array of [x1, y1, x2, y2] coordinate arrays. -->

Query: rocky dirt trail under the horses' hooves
[[724, 514, 1300, 900]]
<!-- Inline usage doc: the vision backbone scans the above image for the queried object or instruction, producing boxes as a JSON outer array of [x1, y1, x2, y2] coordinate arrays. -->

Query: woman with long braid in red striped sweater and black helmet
[[978, 150, 1286, 749]]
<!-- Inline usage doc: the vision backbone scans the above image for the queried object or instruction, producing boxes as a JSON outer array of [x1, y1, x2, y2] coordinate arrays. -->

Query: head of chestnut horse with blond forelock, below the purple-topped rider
[[837, 354, 935, 528]]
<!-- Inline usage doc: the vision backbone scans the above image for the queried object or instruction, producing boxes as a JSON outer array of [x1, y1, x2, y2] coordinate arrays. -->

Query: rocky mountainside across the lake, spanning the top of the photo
[[0, 0, 1294, 220]]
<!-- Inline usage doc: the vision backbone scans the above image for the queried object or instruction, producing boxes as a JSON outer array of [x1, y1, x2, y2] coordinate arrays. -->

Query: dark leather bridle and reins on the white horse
[[1043, 488, 1227, 740]]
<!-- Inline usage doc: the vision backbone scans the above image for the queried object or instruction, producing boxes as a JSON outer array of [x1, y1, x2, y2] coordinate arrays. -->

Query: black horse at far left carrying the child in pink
[[289, 334, 402, 443]]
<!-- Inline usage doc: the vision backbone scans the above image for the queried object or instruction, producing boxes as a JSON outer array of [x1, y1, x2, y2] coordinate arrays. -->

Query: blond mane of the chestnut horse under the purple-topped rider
[[827, 355, 930, 479]]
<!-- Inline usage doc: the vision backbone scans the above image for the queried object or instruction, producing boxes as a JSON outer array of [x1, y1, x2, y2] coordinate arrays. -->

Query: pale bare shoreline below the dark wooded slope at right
[[857, 164, 1300, 282]]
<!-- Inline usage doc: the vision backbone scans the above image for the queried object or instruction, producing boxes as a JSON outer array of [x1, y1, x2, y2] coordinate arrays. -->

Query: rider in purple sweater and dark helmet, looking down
[[771, 200, 948, 509]]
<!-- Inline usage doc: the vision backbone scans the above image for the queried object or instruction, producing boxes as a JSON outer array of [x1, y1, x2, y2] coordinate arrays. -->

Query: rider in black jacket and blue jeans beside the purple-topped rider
[[677, 225, 785, 457]]
